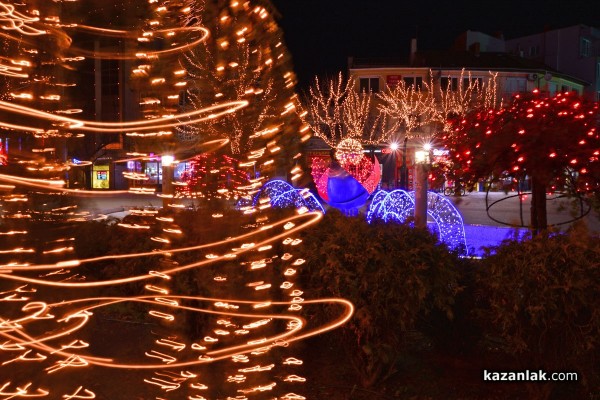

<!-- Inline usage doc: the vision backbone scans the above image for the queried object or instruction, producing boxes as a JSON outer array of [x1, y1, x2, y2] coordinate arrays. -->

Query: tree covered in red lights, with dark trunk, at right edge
[[443, 93, 600, 232]]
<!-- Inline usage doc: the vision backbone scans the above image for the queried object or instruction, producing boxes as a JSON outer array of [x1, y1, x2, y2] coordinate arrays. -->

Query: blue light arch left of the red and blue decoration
[[252, 179, 325, 214]]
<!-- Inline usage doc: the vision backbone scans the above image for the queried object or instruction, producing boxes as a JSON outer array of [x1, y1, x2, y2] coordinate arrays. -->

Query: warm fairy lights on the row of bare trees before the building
[[302, 69, 500, 152]]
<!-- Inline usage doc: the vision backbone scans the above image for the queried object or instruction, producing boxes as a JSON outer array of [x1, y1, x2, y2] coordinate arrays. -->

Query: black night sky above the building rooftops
[[272, 0, 600, 88]]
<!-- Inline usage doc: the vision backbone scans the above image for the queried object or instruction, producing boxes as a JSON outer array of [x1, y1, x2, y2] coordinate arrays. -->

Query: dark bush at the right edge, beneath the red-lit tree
[[478, 225, 600, 398]]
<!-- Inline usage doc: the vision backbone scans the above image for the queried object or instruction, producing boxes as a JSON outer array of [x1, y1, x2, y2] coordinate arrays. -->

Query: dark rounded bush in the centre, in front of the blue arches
[[300, 211, 459, 387]]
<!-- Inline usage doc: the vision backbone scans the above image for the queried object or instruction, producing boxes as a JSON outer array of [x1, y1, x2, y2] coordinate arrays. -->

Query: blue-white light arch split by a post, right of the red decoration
[[367, 190, 468, 256]]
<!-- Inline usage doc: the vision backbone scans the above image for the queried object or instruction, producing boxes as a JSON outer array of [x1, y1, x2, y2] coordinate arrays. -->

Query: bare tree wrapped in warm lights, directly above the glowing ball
[[303, 72, 392, 148]]
